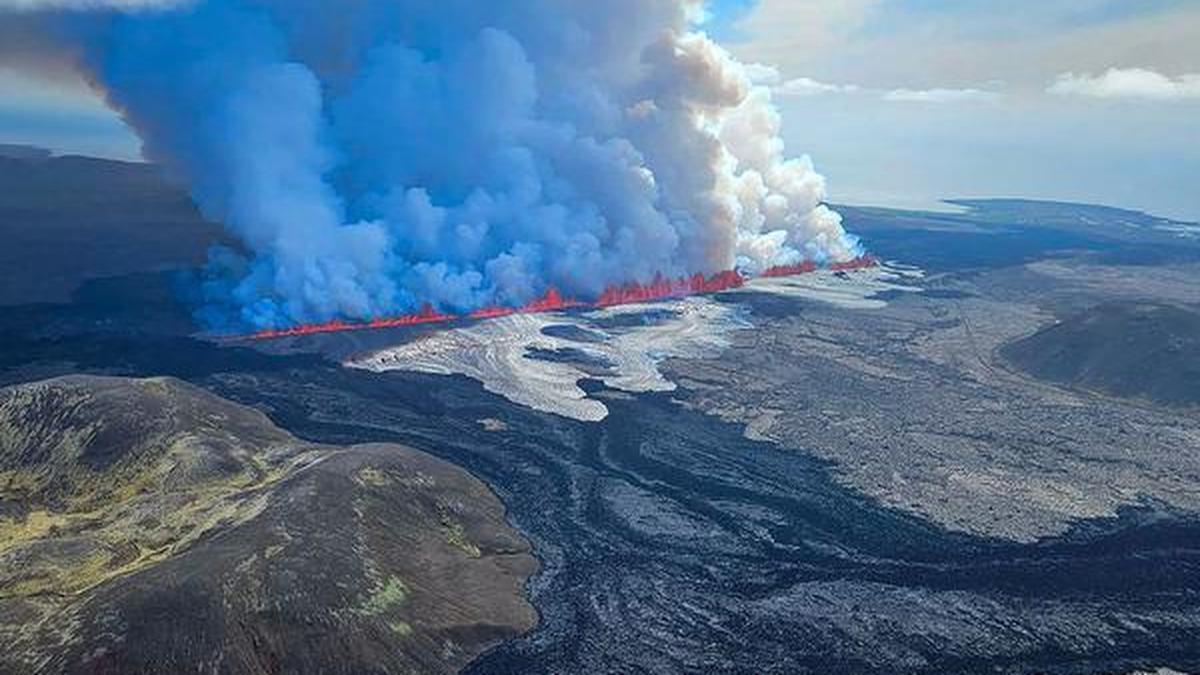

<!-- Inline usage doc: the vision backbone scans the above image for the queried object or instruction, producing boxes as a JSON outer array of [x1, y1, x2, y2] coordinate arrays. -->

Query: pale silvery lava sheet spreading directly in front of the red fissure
[[346, 264, 920, 422]]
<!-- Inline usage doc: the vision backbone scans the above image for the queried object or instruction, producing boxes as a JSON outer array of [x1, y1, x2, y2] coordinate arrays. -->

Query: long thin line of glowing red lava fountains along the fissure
[[229, 256, 880, 340]]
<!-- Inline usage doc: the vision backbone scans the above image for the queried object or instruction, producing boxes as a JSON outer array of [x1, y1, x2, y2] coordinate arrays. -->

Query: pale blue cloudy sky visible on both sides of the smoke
[[0, 0, 1200, 220]]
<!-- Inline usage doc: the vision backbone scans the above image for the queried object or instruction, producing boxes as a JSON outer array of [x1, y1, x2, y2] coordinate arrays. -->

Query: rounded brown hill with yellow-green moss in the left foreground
[[0, 376, 535, 674]]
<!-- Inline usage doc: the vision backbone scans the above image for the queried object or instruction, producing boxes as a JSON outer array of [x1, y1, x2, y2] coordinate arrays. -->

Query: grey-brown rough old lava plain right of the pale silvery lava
[[668, 258, 1200, 542]]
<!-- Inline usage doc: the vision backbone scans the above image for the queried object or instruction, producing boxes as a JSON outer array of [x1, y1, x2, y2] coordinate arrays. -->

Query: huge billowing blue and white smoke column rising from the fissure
[[10, 0, 860, 328]]
